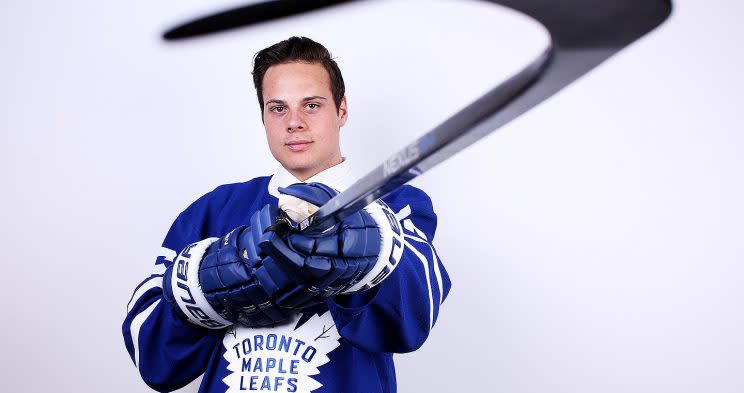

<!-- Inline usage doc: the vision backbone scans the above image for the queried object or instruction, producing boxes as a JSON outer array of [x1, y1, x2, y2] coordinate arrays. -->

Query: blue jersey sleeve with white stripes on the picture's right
[[328, 186, 451, 353]]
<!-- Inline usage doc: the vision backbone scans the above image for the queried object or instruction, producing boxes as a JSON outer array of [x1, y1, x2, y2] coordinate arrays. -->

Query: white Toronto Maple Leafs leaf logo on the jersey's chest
[[222, 311, 341, 393]]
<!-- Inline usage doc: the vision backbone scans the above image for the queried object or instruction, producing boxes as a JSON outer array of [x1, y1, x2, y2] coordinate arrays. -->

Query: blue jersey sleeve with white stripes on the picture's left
[[122, 197, 224, 391]]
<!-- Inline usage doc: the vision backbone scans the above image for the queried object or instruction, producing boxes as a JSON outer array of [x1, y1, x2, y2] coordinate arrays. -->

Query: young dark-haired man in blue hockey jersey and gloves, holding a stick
[[123, 37, 450, 393]]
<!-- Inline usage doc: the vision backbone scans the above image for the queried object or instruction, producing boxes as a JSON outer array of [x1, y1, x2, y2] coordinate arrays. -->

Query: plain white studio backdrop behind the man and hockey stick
[[0, 0, 744, 393]]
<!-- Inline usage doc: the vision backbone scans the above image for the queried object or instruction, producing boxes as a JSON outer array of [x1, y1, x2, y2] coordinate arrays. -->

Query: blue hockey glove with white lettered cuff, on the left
[[163, 205, 289, 329]]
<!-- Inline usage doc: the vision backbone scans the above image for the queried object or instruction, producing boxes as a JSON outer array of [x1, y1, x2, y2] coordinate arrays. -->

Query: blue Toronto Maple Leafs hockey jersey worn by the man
[[122, 162, 450, 393]]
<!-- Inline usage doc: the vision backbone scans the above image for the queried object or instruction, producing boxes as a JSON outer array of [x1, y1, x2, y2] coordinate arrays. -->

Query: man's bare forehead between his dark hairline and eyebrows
[[263, 62, 331, 100]]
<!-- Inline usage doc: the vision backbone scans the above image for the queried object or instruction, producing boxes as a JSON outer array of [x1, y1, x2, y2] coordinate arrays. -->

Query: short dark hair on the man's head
[[253, 37, 346, 113]]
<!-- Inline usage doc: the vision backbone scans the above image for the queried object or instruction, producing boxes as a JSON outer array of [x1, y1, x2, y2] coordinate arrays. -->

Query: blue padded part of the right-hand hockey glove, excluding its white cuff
[[251, 183, 381, 309]]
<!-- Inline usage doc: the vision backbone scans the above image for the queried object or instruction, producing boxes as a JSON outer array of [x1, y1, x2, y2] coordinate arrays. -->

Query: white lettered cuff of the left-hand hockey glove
[[164, 237, 232, 329]]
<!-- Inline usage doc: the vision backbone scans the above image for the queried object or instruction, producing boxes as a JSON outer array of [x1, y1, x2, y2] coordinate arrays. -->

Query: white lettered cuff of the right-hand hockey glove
[[341, 199, 403, 293]]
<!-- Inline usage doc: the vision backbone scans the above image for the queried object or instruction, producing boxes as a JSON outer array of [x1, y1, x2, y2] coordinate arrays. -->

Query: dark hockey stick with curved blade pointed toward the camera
[[164, 0, 672, 230]]
